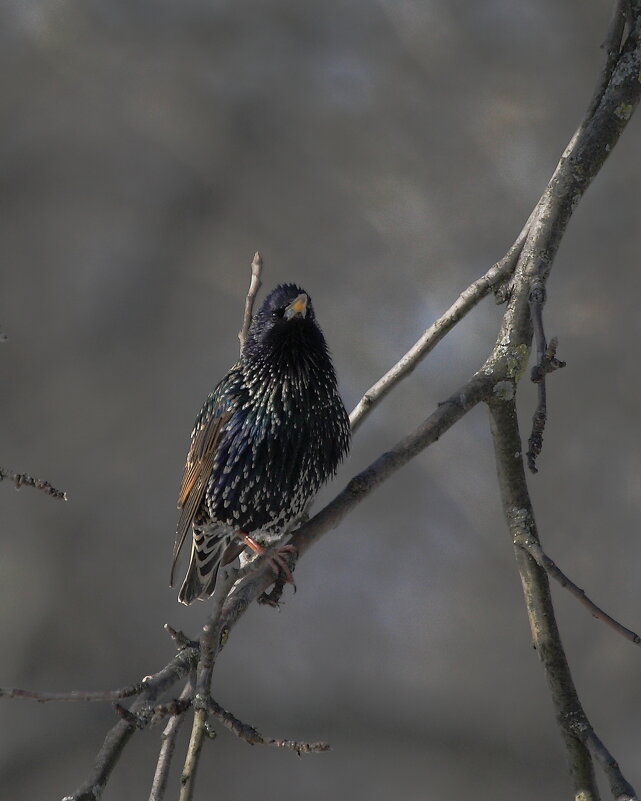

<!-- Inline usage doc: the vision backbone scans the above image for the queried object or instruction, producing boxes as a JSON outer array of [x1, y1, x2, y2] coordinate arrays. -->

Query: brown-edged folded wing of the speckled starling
[[171, 396, 231, 586]]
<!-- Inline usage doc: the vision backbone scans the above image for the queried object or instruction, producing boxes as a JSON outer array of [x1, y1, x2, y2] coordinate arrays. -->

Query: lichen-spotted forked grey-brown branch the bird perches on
[[5, 0, 641, 801]]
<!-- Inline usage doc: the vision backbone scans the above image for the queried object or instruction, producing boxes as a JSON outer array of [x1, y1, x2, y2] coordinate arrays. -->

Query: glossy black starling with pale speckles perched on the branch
[[171, 284, 350, 604]]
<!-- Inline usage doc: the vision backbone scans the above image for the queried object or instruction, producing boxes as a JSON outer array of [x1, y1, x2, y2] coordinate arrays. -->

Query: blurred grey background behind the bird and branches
[[0, 0, 641, 801]]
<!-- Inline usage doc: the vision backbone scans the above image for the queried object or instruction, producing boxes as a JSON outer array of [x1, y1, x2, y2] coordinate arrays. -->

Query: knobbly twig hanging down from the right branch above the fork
[[527, 278, 565, 473]]
